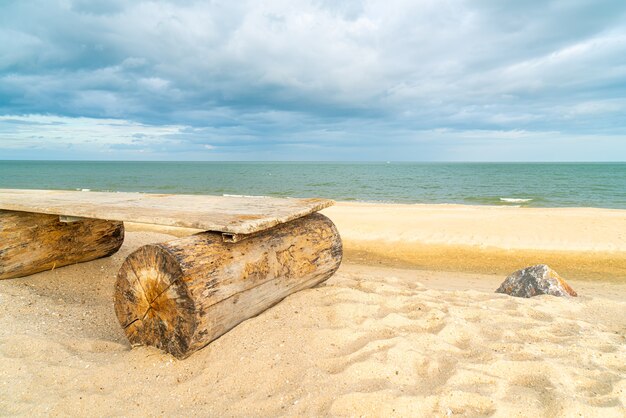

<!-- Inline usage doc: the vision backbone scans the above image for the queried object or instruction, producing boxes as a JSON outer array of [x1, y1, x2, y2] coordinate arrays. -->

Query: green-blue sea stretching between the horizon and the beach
[[0, 161, 626, 209]]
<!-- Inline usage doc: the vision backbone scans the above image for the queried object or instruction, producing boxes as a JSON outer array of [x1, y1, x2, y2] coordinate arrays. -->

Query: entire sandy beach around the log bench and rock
[[0, 202, 626, 417]]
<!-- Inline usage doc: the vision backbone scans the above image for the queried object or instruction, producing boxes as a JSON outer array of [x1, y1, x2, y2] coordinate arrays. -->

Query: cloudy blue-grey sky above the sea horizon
[[0, 0, 626, 161]]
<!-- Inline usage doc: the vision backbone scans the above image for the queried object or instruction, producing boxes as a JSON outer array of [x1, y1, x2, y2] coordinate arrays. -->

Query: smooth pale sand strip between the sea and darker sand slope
[[322, 202, 626, 252]]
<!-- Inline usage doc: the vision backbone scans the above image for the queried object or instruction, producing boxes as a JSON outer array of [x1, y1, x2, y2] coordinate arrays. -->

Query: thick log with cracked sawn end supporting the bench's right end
[[114, 213, 342, 359]]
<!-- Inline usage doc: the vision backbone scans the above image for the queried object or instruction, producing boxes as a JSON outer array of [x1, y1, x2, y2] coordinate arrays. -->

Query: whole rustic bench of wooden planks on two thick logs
[[0, 189, 342, 358]]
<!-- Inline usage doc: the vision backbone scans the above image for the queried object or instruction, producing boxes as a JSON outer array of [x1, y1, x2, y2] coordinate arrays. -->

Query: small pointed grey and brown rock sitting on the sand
[[496, 264, 578, 298]]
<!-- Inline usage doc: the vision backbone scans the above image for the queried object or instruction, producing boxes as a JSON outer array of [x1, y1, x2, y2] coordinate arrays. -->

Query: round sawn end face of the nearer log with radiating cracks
[[115, 244, 196, 358]]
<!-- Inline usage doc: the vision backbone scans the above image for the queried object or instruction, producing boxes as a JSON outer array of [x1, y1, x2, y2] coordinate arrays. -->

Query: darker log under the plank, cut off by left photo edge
[[0, 210, 124, 279]]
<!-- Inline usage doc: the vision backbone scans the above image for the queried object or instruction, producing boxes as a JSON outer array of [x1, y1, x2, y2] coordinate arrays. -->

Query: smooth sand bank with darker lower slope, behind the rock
[[324, 202, 626, 283]]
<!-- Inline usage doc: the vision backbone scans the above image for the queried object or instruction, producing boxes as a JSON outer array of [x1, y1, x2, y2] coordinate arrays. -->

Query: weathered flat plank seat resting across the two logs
[[0, 189, 334, 234]]
